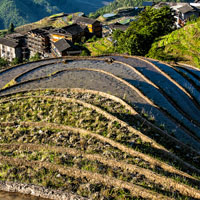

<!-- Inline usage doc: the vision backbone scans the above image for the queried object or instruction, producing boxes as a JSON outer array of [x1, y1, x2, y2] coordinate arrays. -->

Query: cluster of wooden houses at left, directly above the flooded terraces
[[0, 16, 102, 61]]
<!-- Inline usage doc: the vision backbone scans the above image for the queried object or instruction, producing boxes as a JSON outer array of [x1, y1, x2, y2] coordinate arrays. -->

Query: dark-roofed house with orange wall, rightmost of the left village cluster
[[73, 17, 102, 38]]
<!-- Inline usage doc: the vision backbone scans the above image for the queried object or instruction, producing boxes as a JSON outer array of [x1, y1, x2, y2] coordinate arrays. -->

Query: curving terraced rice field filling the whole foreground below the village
[[0, 55, 200, 200]]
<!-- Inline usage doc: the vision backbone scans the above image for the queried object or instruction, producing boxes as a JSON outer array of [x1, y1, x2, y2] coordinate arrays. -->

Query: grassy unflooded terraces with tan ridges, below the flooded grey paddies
[[0, 85, 199, 200]]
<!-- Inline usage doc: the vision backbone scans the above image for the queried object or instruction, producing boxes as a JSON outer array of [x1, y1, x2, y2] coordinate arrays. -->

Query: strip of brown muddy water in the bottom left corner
[[0, 191, 47, 200]]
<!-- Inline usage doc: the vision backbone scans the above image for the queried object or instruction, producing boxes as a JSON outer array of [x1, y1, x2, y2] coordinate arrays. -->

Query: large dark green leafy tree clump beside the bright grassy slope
[[113, 7, 174, 56]]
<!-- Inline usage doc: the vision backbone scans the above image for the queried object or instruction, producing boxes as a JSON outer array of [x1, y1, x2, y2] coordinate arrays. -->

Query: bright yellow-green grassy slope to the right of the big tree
[[148, 19, 200, 67]]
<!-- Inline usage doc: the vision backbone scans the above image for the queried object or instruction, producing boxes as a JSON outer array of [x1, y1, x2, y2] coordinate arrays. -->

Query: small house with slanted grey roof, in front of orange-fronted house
[[51, 39, 81, 57]]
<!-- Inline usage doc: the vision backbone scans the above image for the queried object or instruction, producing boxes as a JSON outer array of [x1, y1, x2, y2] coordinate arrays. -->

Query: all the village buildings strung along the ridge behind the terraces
[[0, 0, 200, 61]]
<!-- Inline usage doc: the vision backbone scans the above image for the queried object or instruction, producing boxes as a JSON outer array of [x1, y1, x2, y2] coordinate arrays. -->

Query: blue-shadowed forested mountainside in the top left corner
[[0, 0, 111, 29]]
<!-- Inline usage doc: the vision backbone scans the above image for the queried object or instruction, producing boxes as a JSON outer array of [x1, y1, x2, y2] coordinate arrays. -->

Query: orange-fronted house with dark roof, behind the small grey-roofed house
[[50, 24, 85, 43]]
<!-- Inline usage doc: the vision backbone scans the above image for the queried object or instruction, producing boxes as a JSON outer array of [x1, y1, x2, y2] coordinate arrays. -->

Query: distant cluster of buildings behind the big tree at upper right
[[103, 0, 200, 37]]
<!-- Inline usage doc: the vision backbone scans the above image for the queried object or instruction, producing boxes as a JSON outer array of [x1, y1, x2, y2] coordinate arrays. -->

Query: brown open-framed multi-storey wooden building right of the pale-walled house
[[27, 28, 50, 58]]
